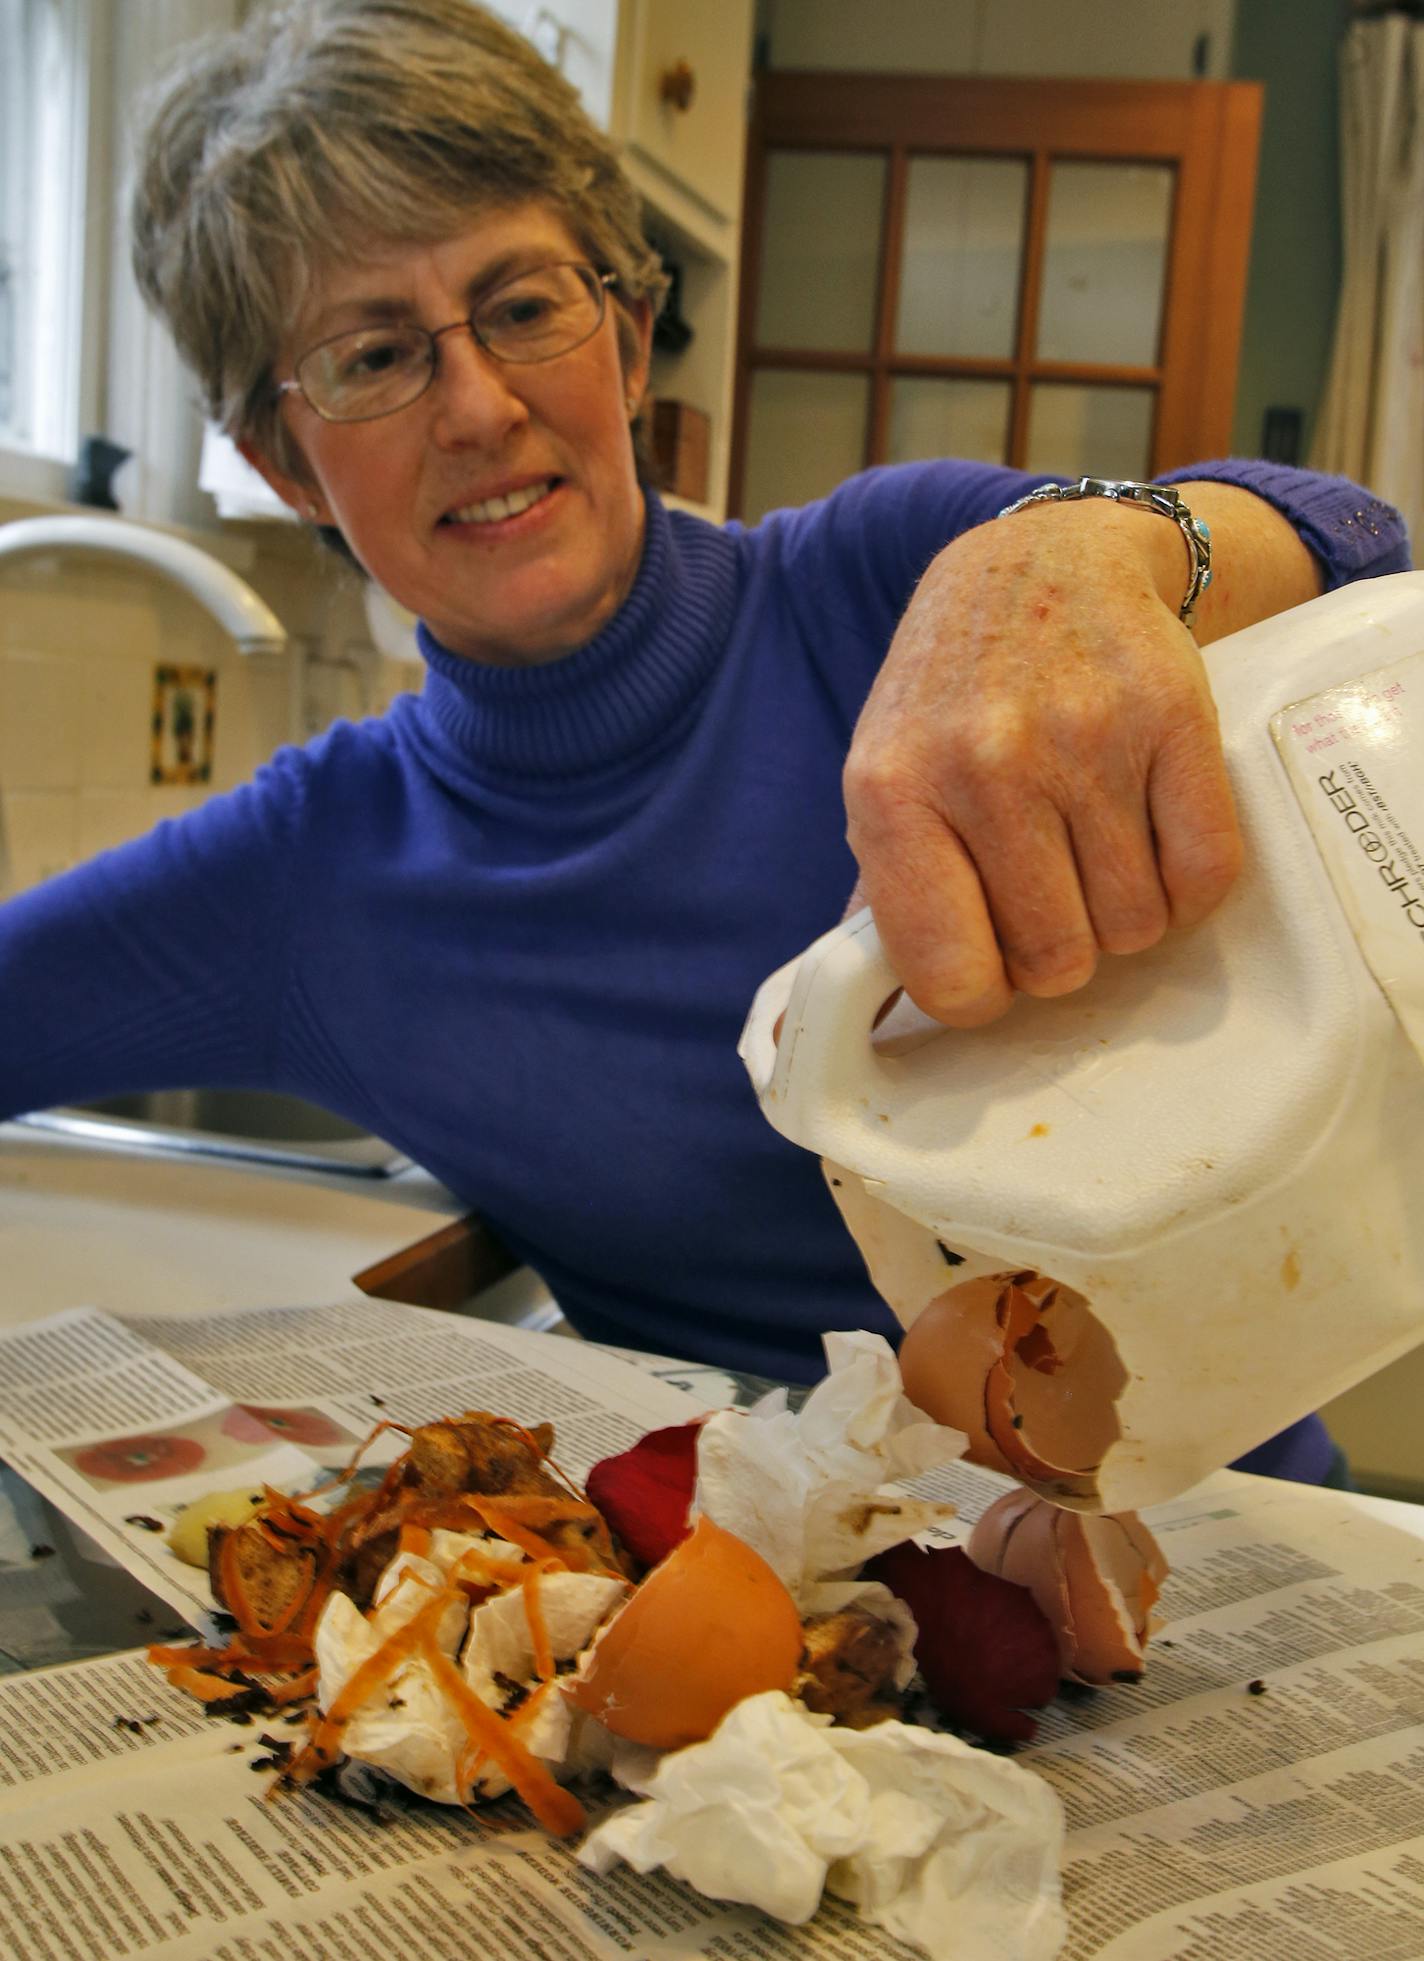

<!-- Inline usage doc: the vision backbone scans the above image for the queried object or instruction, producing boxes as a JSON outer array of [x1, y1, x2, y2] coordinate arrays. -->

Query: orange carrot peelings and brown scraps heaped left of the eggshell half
[[149, 1412, 636, 1834]]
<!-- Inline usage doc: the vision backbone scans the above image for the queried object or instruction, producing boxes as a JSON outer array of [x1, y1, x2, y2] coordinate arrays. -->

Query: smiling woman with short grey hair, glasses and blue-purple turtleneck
[[0, 0, 1404, 1477]]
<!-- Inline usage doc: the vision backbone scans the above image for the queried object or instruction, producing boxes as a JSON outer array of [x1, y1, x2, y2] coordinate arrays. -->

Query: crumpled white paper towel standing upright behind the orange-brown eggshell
[[692, 1330, 969, 1614]]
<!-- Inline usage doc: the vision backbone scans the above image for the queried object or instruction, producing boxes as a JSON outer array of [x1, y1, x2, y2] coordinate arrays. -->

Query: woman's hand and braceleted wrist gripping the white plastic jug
[[845, 484, 1320, 1028]]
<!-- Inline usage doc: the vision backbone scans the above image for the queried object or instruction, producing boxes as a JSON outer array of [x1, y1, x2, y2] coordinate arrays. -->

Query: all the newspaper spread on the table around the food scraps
[[0, 1300, 1424, 1961]]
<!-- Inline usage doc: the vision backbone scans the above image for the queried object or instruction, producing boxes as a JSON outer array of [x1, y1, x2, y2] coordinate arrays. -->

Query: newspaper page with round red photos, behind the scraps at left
[[0, 1294, 728, 1626]]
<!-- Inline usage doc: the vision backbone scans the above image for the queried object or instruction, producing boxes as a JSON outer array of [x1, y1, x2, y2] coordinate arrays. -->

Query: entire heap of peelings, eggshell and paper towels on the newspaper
[[151, 1333, 1155, 1955]]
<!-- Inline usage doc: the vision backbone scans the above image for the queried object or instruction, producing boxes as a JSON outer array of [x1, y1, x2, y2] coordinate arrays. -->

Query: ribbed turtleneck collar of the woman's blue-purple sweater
[[418, 490, 737, 779]]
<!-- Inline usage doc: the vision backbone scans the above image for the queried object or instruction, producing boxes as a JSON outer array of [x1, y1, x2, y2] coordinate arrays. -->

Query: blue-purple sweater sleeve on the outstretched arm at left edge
[[0, 757, 309, 1116]]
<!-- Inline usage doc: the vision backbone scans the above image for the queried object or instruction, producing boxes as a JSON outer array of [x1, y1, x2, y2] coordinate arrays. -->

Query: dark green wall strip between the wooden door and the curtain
[[1230, 0, 1349, 461]]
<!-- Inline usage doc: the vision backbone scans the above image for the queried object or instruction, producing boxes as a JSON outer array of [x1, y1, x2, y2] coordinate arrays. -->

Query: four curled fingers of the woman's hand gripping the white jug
[[847, 674, 1242, 1028]]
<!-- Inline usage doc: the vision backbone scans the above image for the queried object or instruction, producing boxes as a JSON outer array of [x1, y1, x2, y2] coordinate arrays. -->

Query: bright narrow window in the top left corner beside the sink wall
[[0, 0, 102, 490]]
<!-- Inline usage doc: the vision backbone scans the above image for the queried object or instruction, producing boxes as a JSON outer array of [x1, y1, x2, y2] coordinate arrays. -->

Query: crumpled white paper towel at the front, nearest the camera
[[579, 1690, 1067, 1961]]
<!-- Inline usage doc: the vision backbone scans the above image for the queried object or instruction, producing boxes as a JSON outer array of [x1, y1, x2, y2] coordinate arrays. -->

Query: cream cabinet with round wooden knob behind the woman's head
[[486, 0, 753, 518]]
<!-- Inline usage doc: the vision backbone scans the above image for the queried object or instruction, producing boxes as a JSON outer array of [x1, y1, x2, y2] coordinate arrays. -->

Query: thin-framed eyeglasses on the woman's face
[[277, 263, 618, 422]]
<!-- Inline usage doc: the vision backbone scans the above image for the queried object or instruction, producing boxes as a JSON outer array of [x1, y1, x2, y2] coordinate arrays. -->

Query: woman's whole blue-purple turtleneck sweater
[[0, 463, 1406, 1477]]
